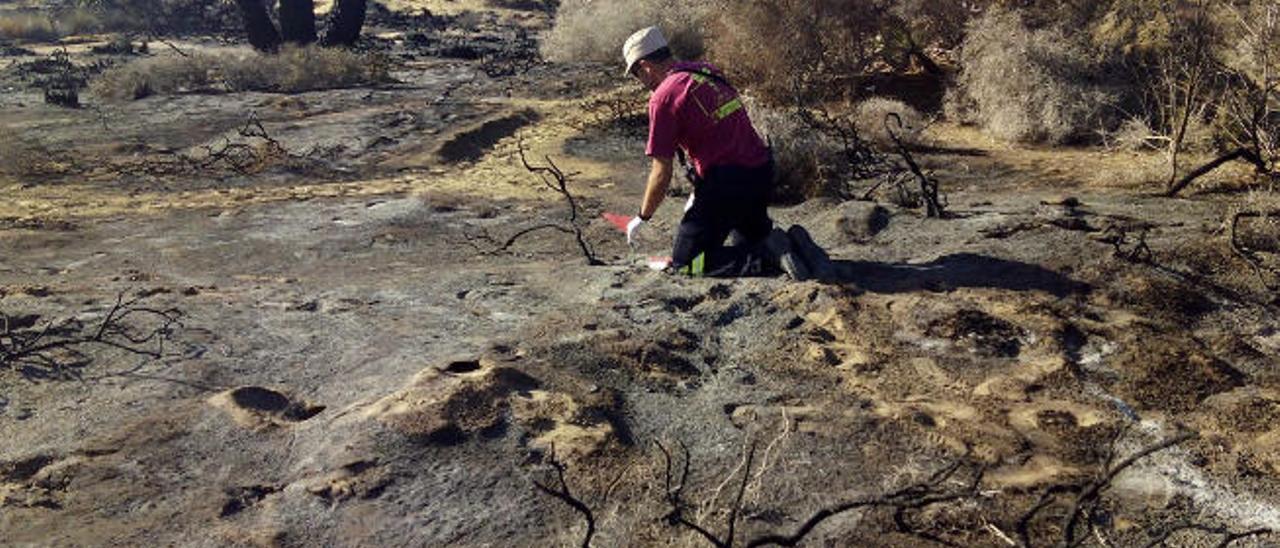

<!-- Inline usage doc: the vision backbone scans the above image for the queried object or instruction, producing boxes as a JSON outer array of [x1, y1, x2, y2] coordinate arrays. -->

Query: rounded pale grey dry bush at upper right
[[947, 9, 1116, 143]]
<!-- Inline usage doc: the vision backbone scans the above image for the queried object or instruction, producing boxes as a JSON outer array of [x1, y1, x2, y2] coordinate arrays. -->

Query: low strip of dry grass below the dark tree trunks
[[90, 47, 389, 101]]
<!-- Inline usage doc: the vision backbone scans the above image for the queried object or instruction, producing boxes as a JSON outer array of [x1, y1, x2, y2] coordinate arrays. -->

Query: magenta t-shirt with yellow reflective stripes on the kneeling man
[[645, 63, 769, 177]]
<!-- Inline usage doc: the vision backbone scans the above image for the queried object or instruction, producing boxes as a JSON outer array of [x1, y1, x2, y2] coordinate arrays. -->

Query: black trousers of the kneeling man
[[671, 161, 773, 277]]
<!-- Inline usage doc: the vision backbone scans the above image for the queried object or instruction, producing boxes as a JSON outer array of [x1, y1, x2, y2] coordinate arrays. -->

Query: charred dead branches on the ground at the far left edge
[[0, 293, 182, 379]]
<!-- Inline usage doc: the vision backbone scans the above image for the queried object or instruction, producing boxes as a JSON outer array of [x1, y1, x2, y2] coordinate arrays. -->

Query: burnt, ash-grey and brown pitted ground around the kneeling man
[[0, 4, 1280, 545]]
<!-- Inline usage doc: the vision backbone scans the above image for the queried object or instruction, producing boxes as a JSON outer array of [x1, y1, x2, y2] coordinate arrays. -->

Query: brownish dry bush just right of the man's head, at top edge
[[709, 0, 883, 105]]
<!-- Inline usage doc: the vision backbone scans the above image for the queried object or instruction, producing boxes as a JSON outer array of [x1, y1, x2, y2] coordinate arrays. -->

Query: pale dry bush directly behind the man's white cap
[[541, 0, 717, 63]]
